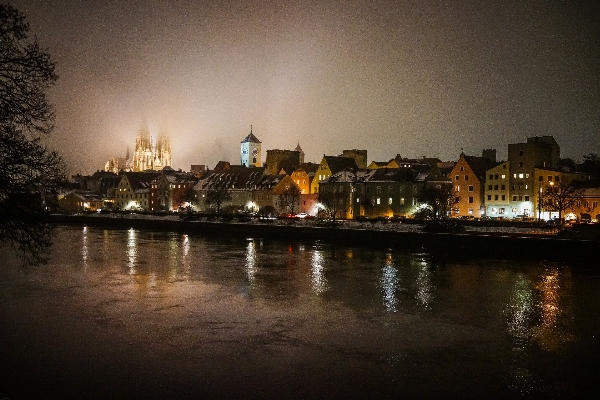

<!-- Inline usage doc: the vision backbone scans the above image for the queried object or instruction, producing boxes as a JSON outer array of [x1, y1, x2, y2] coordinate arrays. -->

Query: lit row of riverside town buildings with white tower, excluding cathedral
[[61, 129, 600, 220]]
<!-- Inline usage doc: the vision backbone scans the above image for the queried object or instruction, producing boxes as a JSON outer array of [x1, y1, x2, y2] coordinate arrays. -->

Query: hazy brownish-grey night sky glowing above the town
[[11, 0, 600, 173]]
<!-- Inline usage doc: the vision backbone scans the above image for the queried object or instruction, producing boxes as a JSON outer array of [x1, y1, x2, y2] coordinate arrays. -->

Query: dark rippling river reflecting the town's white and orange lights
[[0, 227, 600, 399]]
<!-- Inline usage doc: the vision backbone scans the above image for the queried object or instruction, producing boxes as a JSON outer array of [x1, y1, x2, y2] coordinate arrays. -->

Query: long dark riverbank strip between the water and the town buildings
[[51, 214, 599, 260]]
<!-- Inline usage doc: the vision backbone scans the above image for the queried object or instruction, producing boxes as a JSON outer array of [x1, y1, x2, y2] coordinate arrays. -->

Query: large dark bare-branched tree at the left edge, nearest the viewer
[[0, 4, 63, 263]]
